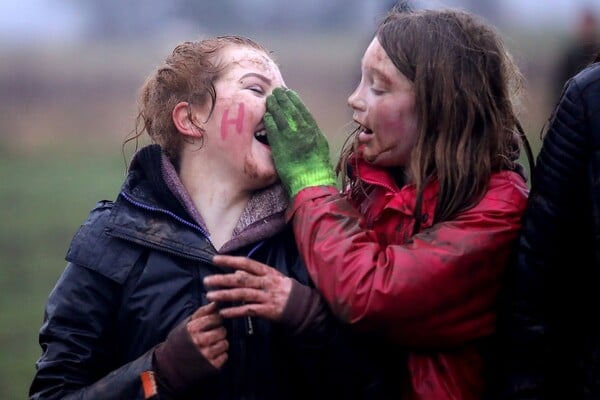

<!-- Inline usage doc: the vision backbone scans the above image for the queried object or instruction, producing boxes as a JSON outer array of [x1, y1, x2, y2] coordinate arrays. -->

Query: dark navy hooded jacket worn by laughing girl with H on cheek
[[30, 145, 382, 399]]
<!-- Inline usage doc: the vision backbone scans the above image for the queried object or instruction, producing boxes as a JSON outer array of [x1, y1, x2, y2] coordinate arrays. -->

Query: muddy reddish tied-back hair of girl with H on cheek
[[124, 36, 271, 165]]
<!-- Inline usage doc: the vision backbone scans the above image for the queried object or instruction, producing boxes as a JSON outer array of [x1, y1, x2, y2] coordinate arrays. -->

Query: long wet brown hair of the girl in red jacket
[[338, 9, 533, 232]]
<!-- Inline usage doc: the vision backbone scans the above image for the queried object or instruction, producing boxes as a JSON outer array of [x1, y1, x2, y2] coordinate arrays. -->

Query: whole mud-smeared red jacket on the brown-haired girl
[[288, 159, 528, 400]]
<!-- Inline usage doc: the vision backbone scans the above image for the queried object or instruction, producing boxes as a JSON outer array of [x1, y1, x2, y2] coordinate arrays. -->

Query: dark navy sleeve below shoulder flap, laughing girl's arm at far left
[[29, 263, 152, 399]]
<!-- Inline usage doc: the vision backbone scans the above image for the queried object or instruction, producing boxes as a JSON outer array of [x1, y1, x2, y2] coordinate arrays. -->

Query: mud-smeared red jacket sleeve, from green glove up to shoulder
[[290, 174, 527, 346]]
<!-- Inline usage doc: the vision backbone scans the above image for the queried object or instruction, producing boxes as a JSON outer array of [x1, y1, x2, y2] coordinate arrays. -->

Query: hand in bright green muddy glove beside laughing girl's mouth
[[263, 88, 336, 197]]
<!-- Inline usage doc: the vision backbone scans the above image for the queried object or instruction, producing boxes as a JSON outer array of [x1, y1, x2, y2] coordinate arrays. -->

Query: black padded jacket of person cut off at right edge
[[501, 63, 600, 400]]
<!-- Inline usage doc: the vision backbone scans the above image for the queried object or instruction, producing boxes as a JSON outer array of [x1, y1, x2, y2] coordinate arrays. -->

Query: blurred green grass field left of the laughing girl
[[0, 145, 124, 399]]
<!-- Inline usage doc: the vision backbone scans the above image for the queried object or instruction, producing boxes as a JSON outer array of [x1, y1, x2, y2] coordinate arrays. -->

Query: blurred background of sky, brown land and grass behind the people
[[0, 0, 600, 399]]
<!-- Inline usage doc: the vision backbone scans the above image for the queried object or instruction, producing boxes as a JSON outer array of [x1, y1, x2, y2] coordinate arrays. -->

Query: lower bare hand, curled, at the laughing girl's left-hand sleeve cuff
[[186, 303, 229, 369]]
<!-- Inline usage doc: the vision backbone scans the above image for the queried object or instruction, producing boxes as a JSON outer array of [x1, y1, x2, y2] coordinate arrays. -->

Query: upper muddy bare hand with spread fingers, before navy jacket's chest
[[204, 255, 292, 321]]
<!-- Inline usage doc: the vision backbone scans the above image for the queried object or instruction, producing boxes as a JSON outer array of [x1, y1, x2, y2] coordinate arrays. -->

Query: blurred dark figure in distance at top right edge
[[552, 9, 600, 101]]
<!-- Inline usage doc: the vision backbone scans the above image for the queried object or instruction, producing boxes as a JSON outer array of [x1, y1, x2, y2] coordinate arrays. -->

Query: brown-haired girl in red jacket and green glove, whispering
[[207, 10, 528, 400]]
